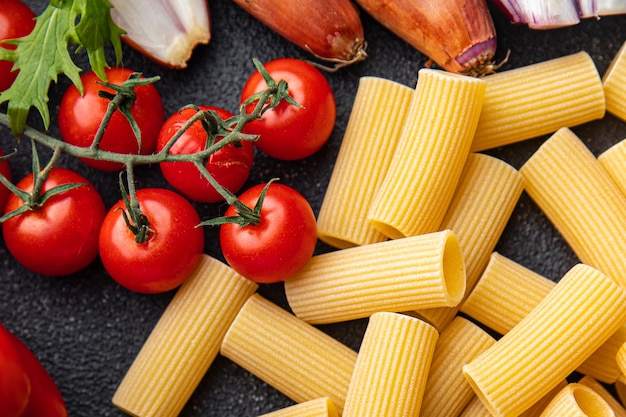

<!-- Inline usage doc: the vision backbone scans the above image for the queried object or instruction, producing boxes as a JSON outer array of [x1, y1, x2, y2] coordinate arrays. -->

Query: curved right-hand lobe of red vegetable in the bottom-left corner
[[2, 329, 68, 417]]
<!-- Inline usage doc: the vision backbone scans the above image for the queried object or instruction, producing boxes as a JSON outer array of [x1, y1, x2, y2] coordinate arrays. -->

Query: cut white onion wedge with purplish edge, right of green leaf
[[110, 0, 211, 69]]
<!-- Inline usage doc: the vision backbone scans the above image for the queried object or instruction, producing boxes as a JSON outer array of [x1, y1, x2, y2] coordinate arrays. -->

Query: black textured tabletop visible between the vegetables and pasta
[[0, 0, 626, 417]]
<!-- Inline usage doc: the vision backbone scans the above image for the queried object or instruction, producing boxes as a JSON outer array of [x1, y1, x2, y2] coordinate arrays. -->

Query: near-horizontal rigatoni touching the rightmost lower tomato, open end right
[[284, 230, 465, 324]]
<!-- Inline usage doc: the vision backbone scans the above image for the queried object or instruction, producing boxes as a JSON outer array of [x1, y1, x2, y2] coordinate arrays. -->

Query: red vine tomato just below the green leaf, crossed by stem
[[59, 67, 165, 171]]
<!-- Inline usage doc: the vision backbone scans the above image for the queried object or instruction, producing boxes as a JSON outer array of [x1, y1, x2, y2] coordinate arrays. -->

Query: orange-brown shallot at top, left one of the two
[[233, 0, 367, 67]]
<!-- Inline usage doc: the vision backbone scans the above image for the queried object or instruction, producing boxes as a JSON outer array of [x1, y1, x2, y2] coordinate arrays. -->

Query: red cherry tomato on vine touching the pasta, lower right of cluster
[[220, 183, 317, 283]]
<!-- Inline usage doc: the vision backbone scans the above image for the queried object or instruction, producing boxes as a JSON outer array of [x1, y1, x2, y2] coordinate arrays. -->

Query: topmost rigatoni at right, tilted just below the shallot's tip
[[471, 52, 606, 152]]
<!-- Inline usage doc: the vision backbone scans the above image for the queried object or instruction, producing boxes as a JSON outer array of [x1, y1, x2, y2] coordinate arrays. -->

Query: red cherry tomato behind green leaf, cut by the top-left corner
[[0, 0, 36, 91]]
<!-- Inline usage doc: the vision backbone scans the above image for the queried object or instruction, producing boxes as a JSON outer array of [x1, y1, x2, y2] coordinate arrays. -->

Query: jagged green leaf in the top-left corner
[[0, 0, 124, 138]]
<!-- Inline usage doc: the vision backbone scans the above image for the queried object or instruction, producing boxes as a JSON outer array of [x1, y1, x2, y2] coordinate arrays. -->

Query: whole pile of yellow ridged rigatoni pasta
[[113, 40, 626, 417]]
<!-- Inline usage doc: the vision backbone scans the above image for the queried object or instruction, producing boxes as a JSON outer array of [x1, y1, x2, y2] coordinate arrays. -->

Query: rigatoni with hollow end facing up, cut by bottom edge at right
[[541, 383, 615, 417]]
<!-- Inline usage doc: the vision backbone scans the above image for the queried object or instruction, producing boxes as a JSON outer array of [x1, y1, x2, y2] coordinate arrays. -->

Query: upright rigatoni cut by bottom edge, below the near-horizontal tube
[[343, 313, 439, 417]]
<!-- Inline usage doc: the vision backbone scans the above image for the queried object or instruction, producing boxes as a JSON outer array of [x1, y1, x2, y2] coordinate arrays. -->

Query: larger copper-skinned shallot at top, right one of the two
[[356, 0, 497, 75]]
